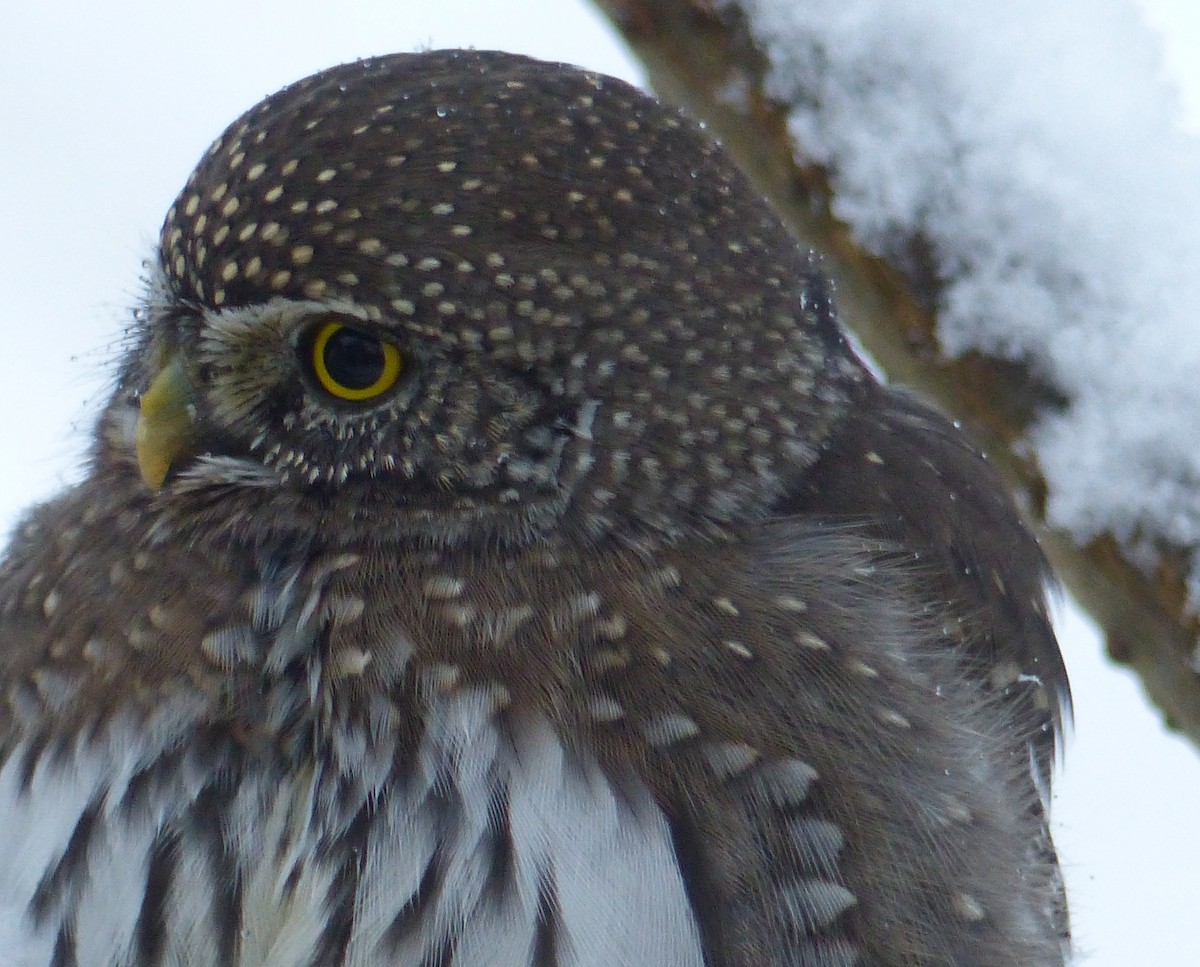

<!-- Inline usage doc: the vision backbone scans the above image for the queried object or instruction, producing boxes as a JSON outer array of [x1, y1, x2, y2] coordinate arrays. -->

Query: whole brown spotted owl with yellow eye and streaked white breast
[[0, 50, 1067, 967]]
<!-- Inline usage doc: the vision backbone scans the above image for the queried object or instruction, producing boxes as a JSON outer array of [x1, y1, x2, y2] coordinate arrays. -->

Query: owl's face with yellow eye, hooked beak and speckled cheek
[[130, 296, 582, 525]]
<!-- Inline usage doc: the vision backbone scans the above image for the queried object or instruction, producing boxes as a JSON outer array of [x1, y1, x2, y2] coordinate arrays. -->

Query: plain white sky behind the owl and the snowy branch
[[0, 0, 1200, 967]]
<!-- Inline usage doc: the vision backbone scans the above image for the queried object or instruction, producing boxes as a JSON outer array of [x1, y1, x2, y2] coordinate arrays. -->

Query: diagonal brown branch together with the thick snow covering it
[[599, 0, 1200, 738]]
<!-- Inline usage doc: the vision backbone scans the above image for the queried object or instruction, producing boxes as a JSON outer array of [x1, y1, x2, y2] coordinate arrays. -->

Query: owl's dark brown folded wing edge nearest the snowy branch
[[781, 384, 1070, 785]]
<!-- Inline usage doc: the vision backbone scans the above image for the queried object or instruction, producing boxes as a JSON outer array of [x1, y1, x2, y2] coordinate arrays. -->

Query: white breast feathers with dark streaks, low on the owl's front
[[0, 690, 703, 967]]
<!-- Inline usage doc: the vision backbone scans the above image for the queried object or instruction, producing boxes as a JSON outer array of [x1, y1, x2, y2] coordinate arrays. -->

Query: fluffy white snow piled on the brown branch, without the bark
[[738, 0, 1200, 602]]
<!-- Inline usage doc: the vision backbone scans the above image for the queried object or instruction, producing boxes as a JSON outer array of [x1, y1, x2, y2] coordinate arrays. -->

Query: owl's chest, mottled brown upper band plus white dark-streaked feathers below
[[0, 537, 703, 967]]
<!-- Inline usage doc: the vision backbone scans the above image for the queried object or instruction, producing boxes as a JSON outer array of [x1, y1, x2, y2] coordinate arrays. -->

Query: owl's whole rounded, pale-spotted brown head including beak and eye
[[118, 52, 862, 549]]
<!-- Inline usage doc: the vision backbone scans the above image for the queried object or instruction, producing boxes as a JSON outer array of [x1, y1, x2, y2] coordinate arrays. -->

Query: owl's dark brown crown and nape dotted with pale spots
[[162, 50, 862, 542]]
